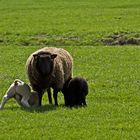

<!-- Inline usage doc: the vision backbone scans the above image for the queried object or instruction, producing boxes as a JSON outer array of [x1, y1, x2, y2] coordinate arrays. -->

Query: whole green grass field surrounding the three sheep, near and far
[[0, 0, 140, 140]]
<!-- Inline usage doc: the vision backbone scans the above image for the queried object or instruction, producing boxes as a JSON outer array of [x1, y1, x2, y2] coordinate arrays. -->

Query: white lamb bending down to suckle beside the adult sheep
[[0, 79, 39, 110]]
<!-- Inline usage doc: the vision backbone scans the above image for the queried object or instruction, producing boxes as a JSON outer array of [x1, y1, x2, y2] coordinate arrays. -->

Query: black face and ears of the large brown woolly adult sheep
[[33, 53, 57, 76]]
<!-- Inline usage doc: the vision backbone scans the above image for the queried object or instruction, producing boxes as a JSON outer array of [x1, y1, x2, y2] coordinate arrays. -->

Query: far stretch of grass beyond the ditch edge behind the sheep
[[0, 0, 140, 46]]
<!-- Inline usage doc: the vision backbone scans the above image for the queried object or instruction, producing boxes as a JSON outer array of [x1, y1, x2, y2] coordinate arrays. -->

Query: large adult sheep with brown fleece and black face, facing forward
[[26, 47, 73, 106]]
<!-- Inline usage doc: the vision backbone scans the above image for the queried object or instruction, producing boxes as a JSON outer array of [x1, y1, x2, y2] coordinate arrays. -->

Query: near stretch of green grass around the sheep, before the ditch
[[0, 46, 140, 139]]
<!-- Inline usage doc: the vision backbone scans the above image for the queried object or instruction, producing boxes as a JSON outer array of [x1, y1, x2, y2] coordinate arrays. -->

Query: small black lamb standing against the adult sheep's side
[[62, 77, 88, 107]]
